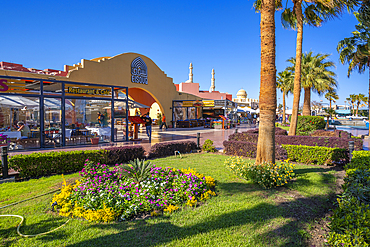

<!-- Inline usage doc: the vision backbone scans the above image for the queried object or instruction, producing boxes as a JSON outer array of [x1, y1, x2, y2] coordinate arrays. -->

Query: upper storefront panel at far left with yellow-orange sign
[[0, 77, 40, 94]]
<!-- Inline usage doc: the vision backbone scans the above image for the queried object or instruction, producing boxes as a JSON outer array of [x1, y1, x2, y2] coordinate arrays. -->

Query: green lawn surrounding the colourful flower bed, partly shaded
[[0, 154, 335, 246]]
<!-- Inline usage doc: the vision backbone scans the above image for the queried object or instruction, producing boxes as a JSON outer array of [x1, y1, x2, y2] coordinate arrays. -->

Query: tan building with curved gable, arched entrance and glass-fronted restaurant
[[0, 53, 202, 150]]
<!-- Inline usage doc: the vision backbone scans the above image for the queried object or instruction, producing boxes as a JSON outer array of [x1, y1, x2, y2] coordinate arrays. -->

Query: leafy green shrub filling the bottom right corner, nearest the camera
[[328, 197, 370, 246]]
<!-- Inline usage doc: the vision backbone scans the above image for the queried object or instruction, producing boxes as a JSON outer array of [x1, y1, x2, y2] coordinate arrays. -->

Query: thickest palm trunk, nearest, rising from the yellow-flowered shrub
[[256, 0, 276, 164]]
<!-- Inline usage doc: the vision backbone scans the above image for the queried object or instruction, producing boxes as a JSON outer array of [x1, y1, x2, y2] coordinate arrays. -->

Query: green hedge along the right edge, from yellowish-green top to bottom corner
[[328, 151, 370, 246]]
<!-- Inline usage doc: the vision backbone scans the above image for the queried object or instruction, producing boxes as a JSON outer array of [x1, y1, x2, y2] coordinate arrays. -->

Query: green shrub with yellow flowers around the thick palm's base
[[225, 156, 294, 189]]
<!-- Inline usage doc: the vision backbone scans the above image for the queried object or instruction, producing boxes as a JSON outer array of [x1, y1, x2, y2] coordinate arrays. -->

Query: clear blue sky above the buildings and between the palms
[[0, 0, 369, 106]]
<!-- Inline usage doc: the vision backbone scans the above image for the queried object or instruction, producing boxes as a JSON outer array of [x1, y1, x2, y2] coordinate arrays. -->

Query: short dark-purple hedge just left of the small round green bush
[[148, 141, 197, 159]]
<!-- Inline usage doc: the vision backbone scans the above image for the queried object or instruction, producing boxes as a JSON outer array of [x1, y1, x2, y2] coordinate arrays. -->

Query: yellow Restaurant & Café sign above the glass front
[[64, 83, 112, 98]]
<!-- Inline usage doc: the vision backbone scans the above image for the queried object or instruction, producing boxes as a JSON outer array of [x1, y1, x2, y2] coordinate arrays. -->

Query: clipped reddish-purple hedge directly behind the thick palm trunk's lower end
[[223, 141, 287, 160]]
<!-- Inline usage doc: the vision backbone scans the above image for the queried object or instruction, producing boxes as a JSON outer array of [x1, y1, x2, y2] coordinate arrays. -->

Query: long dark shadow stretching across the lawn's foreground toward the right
[[63, 196, 336, 246]]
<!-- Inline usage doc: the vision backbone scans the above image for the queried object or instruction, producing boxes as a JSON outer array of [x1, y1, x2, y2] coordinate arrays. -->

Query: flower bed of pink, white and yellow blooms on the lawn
[[51, 162, 216, 222]]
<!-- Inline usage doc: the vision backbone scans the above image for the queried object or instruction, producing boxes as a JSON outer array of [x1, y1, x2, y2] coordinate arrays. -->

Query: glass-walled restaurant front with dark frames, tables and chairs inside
[[0, 76, 129, 150]]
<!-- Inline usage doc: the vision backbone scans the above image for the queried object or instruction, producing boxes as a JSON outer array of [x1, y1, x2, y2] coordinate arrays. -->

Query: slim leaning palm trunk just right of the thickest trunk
[[289, 0, 303, 136]]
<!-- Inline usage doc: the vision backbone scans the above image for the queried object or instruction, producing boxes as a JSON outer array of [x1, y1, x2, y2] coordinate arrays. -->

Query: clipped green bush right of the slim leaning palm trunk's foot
[[289, 116, 325, 135]]
